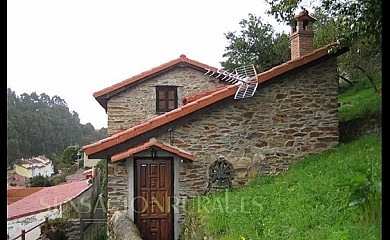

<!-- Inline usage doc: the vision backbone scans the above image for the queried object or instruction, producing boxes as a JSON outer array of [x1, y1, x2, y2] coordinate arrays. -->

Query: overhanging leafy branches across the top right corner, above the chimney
[[266, 0, 382, 49]]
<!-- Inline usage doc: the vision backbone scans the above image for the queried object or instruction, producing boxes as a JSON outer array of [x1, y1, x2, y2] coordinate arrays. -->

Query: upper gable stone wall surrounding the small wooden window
[[107, 67, 227, 136]]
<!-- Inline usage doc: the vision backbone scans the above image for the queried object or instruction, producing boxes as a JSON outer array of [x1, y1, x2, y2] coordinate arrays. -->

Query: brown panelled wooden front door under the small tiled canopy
[[134, 159, 173, 240]]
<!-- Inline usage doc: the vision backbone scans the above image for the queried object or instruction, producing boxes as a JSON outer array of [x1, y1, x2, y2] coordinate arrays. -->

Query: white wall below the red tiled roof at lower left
[[7, 208, 62, 240]]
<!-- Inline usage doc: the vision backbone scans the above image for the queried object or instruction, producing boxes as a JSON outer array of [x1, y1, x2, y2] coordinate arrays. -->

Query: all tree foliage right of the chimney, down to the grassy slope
[[266, 0, 382, 92]]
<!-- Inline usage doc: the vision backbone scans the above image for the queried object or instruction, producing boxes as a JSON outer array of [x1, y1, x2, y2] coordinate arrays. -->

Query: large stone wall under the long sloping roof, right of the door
[[159, 59, 339, 196]]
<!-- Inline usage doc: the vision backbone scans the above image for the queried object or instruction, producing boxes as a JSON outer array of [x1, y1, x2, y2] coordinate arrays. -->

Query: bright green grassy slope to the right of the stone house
[[181, 77, 382, 240]]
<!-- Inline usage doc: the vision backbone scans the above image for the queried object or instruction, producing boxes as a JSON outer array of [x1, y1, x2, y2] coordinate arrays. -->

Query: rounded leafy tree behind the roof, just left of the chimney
[[221, 14, 290, 72]]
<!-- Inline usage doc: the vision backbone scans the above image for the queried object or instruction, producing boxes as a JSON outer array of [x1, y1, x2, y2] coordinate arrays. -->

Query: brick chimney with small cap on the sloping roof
[[290, 9, 316, 59]]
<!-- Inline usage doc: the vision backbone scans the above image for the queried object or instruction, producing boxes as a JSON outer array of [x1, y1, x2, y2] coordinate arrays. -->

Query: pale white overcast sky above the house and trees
[[7, 0, 289, 129]]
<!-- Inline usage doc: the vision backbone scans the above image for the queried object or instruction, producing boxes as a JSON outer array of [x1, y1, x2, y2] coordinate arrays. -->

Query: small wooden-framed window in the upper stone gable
[[156, 86, 177, 113]]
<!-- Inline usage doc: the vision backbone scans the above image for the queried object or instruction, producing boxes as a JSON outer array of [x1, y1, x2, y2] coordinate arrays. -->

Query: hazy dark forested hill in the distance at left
[[7, 88, 107, 167]]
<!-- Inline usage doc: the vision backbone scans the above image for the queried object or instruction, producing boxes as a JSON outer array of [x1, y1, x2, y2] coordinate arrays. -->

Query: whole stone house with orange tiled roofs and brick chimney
[[83, 12, 348, 239]]
